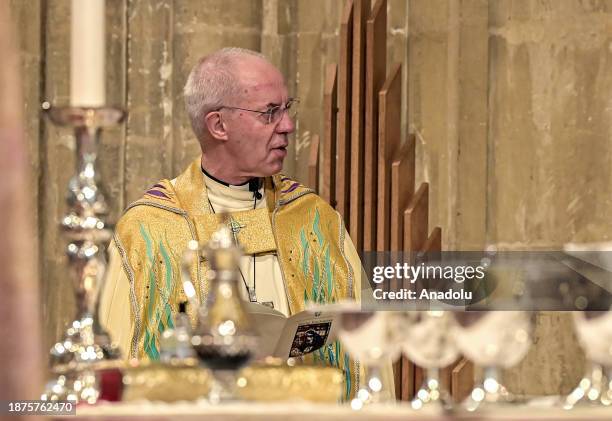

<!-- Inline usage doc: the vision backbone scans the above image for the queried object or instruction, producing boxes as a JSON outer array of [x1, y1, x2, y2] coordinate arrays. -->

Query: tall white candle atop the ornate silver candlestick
[[70, 0, 106, 107]]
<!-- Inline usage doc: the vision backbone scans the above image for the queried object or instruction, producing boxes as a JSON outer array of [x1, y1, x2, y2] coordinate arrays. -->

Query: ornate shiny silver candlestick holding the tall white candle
[[43, 102, 125, 403]]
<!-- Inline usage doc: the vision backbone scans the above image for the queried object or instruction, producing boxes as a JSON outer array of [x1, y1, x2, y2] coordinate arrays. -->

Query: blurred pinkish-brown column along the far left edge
[[0, 2, 42, 419]]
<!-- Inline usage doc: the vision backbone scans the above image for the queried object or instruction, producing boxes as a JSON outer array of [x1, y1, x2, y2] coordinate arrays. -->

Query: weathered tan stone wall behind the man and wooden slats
[[10, 0, 612, 392]]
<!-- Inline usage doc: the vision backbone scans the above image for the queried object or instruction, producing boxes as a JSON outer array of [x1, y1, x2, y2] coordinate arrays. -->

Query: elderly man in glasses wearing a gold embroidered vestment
[[101, 48, 361, 395]]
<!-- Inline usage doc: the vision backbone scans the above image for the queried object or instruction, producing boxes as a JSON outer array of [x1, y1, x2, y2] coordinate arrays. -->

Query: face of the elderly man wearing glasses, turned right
[[222, 57, 295, 177]]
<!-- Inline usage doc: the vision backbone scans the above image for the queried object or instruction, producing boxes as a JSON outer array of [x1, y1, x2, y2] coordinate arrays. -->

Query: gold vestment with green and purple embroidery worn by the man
[[102, 158, 361, 397]]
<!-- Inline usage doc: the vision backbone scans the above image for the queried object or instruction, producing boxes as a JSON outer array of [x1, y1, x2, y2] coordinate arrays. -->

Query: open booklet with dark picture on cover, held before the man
[[245, 303, 338, 359]]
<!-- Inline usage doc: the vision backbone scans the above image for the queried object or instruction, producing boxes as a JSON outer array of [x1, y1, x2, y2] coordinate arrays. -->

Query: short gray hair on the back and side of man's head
[[183, 47, 267, 141]]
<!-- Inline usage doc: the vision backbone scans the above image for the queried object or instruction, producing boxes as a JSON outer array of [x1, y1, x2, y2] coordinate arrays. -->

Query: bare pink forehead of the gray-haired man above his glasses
[[234, 57, 287, 105]]
